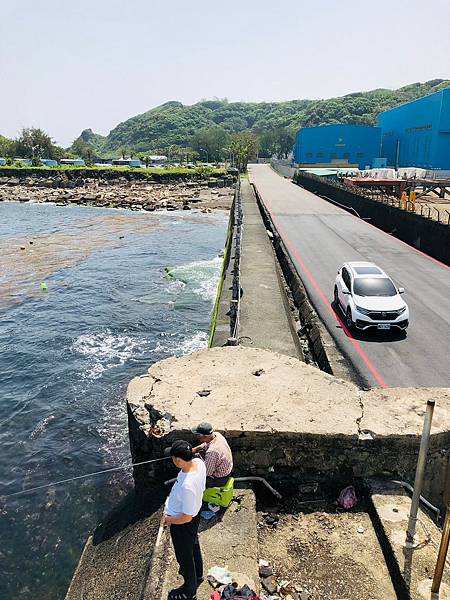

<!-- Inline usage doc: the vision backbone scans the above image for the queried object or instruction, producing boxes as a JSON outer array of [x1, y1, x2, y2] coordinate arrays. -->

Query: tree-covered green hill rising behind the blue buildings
[[67, 79, 450, 155]]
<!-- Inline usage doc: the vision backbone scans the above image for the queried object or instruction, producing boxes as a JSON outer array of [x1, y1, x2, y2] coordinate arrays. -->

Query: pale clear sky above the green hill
[[0, 0, 450, 146]]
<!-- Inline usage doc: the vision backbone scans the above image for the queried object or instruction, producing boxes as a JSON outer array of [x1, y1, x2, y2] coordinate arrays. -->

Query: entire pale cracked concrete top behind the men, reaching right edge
[[128, 347, 450, 440]]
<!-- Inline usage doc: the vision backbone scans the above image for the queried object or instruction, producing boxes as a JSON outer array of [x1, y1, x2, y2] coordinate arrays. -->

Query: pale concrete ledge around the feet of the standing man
[[150, 489, 259, 600]]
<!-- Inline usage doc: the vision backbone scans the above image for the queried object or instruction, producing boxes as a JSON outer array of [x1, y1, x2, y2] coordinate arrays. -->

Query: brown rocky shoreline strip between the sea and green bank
[[0, 176, 234, 212]]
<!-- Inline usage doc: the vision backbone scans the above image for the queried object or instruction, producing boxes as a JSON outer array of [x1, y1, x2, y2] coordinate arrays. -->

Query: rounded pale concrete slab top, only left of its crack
[[128, 347, 360, 436]]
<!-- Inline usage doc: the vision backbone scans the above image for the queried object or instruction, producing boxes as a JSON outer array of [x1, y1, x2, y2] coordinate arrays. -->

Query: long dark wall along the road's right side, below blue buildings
[[295, 172, 450, 265]]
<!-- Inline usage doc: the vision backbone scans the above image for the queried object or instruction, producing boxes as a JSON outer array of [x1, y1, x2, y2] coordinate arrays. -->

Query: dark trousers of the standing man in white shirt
[[170, 513, 203, 596]]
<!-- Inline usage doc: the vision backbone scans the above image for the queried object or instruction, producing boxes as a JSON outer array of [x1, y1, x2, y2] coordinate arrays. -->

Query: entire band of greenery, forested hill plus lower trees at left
[[0, 79, 450, 172]]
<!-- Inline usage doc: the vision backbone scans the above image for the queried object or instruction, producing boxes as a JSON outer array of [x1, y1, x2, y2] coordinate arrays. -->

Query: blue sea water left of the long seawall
[[0, 203, 227, 600]]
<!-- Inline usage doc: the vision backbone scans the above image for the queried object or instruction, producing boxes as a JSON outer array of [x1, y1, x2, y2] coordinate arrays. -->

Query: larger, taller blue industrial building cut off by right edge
[[378, 89, 450, 169]]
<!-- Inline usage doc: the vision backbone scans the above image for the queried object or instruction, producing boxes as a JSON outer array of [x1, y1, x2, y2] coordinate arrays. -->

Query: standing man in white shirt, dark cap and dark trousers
[[165, 440, 206, 600]]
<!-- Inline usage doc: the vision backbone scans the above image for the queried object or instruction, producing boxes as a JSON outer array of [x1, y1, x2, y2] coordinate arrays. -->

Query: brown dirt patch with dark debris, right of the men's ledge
[[258, 490, 396, 600]]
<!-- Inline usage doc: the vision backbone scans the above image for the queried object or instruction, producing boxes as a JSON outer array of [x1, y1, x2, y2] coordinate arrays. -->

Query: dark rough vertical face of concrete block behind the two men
[[129, 419, 450, 510]]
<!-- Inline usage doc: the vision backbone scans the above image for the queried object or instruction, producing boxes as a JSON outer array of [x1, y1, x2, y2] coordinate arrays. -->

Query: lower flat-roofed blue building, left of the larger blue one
[[294, 124, 381, 169]]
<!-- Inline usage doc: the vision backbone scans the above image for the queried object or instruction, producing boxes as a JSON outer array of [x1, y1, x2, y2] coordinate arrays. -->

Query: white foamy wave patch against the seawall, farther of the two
[[167, 256, 223, 301]]
